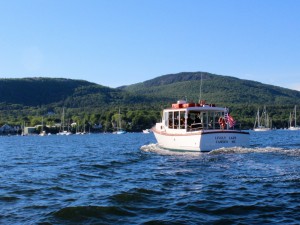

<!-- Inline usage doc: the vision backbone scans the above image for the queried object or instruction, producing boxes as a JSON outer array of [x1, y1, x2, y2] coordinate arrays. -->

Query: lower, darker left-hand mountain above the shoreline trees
[[0, 78, 139, 108]]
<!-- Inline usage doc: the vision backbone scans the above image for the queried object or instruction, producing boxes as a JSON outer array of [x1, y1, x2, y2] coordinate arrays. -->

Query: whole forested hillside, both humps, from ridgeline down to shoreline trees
[[0, 72, 300, 131]]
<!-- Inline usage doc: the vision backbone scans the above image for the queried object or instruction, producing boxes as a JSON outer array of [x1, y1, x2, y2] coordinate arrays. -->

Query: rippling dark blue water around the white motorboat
[[0, 130, 300, 224]]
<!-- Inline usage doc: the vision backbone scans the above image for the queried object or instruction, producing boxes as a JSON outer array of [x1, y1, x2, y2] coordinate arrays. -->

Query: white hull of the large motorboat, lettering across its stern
[[153, 128, 249, 152]]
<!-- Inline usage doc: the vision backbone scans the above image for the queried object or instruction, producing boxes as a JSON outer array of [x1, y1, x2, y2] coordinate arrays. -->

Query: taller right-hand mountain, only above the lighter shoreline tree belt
[[119, 72, 300, 105]]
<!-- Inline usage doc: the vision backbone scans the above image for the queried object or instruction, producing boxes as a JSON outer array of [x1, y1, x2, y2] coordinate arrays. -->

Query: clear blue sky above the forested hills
[[0, 0, 300, 91]]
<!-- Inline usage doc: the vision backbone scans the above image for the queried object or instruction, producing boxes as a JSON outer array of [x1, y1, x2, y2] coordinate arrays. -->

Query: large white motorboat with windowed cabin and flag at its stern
[[152, 100, 250, 152]]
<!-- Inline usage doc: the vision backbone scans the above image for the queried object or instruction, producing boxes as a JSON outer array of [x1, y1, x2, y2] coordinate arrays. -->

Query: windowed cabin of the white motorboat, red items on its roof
[[162, 101, 227, 131]]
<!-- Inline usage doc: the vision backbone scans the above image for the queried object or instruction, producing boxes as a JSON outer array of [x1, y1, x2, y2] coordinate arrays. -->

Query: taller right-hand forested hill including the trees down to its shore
[[120, 72, 300, 129]]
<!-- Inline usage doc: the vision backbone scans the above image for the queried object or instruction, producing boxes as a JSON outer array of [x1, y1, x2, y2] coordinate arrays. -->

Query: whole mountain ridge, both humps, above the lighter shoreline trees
[[0, 72, 300, 108]]
